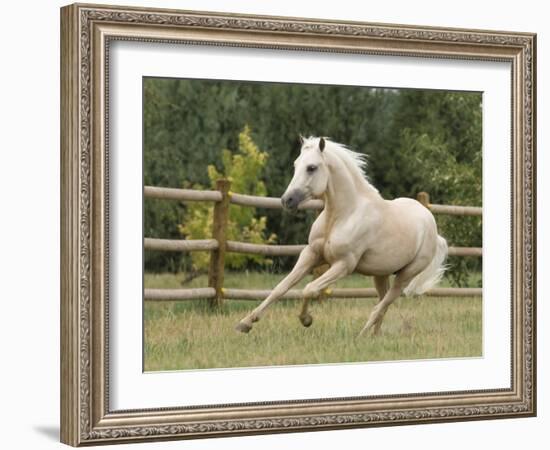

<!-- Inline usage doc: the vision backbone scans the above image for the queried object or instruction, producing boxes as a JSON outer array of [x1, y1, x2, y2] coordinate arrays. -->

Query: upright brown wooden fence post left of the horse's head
[[208, 179, 231, 307]]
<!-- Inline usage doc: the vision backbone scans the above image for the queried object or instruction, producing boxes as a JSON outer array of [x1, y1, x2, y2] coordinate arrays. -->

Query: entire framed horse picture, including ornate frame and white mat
[[61, 4, 536, 446]]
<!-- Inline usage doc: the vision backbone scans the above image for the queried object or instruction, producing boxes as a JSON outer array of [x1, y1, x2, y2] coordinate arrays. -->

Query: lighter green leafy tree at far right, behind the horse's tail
[[396, 91, 482, 286]]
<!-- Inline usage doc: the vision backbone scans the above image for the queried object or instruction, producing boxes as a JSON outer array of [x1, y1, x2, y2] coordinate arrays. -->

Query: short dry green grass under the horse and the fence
[[144, 272, 482, 371]]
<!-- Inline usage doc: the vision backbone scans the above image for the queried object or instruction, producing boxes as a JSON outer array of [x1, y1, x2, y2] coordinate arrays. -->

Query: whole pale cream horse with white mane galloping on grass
[[236, 137, 448, 334]]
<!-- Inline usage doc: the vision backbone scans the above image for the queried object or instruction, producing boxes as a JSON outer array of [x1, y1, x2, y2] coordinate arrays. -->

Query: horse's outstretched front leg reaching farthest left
[[235, 245, 319, 333]]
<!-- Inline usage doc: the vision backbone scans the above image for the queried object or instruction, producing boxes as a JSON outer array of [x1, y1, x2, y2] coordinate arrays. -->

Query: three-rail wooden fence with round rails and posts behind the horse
[[144, 180, 482, 306]]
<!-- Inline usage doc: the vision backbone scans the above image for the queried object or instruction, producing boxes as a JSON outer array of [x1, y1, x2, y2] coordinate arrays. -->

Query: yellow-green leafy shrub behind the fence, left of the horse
[[180, 126, 276, 270]]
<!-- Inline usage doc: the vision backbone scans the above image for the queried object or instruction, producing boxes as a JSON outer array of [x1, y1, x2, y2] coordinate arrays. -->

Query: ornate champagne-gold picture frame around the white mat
[[61, 4, 536, 446]]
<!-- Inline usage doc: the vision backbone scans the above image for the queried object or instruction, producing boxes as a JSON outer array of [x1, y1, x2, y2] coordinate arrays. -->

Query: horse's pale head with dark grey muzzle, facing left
[[281, 138, 328, 209]]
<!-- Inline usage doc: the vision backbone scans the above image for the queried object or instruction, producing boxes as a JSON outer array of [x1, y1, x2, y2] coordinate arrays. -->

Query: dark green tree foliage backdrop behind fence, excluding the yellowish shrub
[[143, 78, 482, 285]]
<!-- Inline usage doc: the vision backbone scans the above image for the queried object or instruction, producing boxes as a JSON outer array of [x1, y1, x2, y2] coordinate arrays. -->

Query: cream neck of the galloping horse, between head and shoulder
[[325, 151, 382, 217]]
